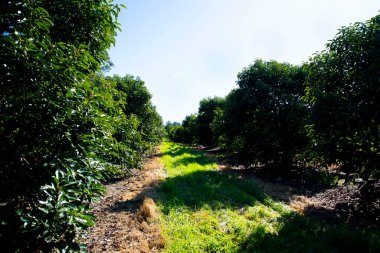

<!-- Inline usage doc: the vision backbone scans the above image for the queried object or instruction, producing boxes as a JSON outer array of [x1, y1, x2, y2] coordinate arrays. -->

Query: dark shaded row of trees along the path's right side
[[166, 15, 380, 188]]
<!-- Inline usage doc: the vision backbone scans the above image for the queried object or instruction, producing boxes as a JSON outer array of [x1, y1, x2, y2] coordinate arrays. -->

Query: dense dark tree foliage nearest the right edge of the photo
[[305, 15, 380, 183]]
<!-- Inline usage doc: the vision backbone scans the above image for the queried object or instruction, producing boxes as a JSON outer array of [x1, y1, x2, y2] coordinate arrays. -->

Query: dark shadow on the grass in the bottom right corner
[[239, 213, 380, 253]]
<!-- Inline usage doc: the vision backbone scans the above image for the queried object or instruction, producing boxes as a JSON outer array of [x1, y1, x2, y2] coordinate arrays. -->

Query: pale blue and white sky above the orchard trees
[[109, 0, 380, 122]]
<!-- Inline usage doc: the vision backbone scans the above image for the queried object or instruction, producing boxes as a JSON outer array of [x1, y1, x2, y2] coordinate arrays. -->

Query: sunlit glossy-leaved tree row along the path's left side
[[0, 0, 163, 252]]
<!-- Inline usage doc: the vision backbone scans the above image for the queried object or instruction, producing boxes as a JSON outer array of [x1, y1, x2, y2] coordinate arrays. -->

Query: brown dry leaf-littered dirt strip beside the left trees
[[84, 157, 165, 253]]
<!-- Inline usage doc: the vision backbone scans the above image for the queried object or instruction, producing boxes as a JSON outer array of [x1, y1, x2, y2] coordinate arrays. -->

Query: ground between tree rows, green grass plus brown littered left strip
[[82, 142, 380, 253]]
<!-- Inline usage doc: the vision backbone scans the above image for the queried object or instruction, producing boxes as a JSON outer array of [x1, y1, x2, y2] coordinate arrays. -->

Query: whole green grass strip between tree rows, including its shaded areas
[[158, 142, 380, 253]]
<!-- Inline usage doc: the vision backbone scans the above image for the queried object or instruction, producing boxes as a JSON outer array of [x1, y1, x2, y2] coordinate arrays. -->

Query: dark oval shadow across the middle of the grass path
[[160, 171, 266, 213]]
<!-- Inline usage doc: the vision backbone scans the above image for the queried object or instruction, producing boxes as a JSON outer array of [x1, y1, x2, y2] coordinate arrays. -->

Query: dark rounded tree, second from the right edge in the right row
[[219, 60, 306, 169]]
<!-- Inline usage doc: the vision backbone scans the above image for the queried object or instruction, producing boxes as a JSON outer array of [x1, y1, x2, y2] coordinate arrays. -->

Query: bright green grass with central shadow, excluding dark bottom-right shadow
[[159, 142, 288, 252]]
